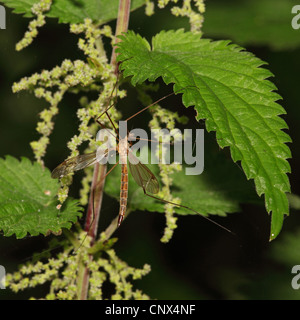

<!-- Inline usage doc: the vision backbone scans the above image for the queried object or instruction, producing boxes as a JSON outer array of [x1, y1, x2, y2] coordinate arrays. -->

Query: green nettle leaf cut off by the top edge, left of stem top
[[1, 0, 145, 24]]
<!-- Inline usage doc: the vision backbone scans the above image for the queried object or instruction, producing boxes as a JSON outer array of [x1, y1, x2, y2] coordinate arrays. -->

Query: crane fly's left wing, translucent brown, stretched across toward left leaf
[[51, 152, 98, 179]]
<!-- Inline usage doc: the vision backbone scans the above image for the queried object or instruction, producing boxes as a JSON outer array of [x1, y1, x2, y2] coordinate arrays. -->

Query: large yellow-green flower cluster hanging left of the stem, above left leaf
[[13, 19, 125, 204]]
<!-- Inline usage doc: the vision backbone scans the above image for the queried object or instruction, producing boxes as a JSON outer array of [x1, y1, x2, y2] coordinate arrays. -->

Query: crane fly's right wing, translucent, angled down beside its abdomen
[[128, 152, 159, 194]]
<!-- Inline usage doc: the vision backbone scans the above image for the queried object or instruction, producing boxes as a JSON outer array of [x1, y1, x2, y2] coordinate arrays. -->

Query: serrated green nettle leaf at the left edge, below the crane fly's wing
[[0, 156, 81, 239]]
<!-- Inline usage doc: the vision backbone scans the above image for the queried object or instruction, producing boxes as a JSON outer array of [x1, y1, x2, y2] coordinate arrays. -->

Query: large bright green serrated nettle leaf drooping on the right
[[117, 30, 291, 239]]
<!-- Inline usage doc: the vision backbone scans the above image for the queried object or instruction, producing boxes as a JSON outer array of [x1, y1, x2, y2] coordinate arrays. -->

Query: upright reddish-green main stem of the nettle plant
[[78, 0, 131, 300]]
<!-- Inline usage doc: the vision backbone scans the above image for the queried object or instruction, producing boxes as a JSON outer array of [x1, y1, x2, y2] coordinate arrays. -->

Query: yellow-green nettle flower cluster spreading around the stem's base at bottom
[[6, 232, 151, 300]]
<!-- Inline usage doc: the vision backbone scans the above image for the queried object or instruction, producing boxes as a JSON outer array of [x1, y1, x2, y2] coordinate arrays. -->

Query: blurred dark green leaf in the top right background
[[203, 0, 300, 50]]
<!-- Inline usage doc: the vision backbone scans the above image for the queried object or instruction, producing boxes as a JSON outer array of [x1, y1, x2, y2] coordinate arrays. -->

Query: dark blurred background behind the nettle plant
[[0, 0, 300, 299]]
